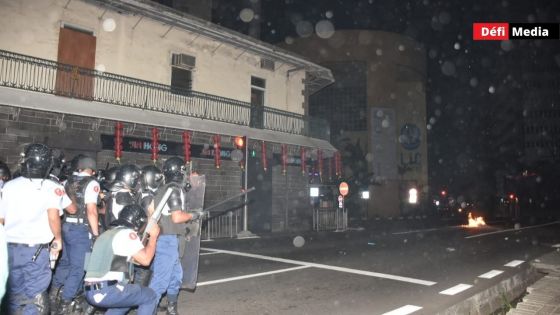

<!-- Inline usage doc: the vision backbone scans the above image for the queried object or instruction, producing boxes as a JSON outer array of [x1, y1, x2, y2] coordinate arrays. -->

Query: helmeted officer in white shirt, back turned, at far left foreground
[[0, 144, 64, 314]]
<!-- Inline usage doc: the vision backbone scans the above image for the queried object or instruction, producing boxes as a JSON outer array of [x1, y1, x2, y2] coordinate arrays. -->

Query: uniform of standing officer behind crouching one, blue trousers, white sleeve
[[51, 172, 100, 304]]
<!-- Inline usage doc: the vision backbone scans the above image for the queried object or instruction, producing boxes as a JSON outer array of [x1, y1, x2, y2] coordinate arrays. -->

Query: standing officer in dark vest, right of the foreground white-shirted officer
[[51, 155, 100, 315]]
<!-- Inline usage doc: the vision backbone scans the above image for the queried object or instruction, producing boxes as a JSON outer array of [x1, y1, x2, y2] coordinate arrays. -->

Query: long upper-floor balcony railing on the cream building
[[0, 50, 330, 140]]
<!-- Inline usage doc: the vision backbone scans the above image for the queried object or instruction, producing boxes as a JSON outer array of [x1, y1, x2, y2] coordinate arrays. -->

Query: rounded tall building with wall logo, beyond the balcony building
[[282, 30, 428, 217]]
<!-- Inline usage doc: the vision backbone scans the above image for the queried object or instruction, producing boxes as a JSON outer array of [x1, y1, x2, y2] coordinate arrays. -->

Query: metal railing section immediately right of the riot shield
[[202, 210, 241, 240]]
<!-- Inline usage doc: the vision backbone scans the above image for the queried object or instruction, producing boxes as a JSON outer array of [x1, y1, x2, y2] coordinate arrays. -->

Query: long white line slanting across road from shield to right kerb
[[201, 247, 437, 286]]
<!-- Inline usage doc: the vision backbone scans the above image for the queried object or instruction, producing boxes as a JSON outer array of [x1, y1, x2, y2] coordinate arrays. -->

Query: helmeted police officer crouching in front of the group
[[84, 204, 159, 315]]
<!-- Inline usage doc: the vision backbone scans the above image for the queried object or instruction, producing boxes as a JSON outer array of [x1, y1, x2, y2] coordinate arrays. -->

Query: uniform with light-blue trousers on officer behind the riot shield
[[150, 183, 186, 312]]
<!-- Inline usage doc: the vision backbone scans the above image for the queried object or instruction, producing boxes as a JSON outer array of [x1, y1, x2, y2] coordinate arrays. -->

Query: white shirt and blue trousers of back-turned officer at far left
[[0, 176, 64, 314]]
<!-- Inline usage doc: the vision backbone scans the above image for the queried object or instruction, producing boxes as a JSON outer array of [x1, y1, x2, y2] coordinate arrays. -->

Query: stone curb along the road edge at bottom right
[[436, 266, 543, 315]]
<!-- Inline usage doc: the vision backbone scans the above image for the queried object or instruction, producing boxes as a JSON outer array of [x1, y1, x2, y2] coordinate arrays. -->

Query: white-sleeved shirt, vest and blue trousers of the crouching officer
[[84, 226, 158, 315]]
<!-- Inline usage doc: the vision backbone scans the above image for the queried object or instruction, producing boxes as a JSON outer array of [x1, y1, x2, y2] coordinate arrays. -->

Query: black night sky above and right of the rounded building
[[213, 0, 560, 205]]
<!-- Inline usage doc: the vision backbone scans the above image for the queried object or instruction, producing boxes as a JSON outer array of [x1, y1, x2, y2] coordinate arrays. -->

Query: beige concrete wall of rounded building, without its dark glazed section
[[281, 30, 428, 216]]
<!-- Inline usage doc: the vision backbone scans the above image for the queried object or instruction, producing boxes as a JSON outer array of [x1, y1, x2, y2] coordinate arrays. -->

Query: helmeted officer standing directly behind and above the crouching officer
[[105, 164, 140, 225]]
